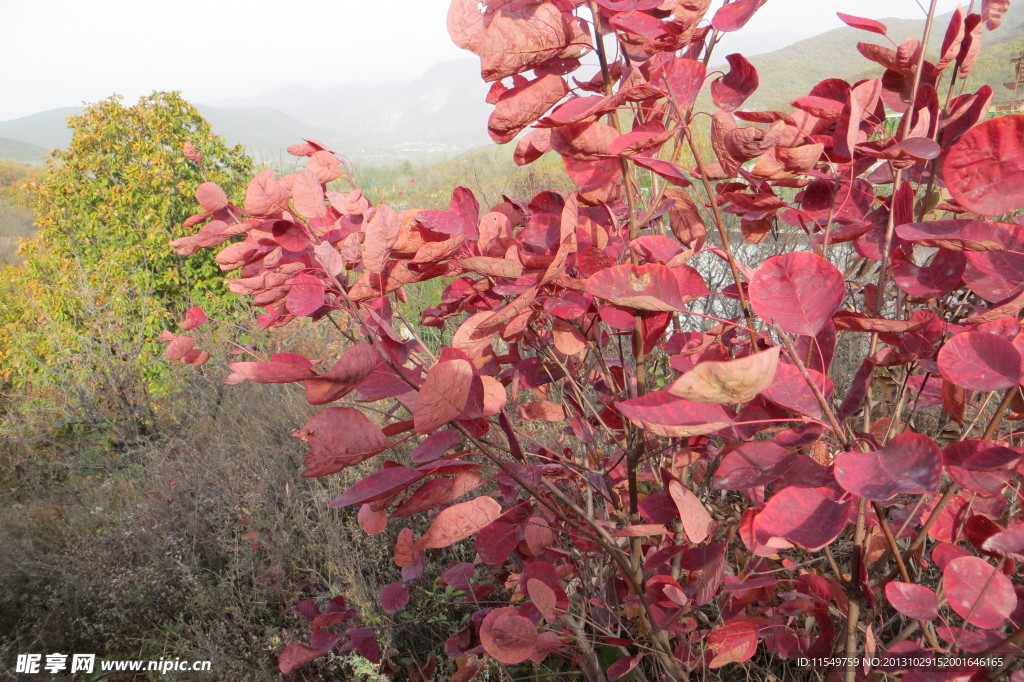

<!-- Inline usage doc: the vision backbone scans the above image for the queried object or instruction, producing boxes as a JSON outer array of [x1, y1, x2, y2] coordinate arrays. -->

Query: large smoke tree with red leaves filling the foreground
[[165, 0, 1024, 680]]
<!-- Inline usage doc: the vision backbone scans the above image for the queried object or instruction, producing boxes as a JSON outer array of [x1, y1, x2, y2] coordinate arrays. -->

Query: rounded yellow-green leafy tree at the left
[[0, 92, 252, 434]]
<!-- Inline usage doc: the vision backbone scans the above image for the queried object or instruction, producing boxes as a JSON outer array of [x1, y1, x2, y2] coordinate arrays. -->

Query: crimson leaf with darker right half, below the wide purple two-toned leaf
[[754, 485, 852, 552]]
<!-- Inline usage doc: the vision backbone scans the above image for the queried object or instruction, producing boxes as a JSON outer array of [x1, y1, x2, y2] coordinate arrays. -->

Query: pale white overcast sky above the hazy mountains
[[0, 0, 966, 121]]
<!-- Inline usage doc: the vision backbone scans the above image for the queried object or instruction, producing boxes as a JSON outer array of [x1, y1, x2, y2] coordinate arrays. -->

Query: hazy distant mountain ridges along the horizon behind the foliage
[[0, 10, 1024, 165]]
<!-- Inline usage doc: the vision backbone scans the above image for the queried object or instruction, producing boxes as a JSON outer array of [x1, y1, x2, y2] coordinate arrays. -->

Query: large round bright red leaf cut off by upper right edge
[[942, 114, 1024, 216]]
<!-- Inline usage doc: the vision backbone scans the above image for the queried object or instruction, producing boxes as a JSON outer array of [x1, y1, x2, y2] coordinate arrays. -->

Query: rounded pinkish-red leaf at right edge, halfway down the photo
[[937, 332, 1024, 391]]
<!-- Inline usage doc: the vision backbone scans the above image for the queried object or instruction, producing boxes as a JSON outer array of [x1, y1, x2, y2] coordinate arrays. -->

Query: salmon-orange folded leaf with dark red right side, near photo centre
[[413, 358, 483, 433]]
